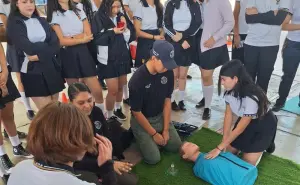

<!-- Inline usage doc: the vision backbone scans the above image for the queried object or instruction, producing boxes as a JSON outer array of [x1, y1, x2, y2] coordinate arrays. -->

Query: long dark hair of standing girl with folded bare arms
[[47, 0, 80, 22]]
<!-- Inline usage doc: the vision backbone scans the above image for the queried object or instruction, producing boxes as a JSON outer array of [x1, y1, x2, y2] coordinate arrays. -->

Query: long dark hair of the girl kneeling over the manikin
[[218, 60, 270, 118]]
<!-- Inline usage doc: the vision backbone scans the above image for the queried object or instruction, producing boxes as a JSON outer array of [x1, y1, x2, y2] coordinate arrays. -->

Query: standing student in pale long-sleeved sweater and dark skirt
[[196, 0, 234, 120]]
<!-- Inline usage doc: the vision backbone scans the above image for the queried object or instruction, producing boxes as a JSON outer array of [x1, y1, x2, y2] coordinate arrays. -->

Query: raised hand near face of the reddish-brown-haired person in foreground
[[95, 134, 112, 166]]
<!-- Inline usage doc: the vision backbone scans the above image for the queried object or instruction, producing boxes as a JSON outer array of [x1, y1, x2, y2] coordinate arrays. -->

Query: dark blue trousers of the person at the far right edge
[[276, 39, 300, 105]]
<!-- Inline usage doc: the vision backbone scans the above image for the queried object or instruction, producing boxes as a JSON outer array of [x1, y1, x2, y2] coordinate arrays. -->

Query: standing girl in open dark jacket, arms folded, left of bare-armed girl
[[7, 0, 65, 109]]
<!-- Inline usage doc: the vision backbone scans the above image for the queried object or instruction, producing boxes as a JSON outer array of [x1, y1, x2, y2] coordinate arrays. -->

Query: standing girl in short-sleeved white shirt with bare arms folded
[[47, 0, 104, 110]]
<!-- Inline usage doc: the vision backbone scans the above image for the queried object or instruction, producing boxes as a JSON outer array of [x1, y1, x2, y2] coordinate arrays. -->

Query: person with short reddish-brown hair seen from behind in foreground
[[8, 102, 116, 185]]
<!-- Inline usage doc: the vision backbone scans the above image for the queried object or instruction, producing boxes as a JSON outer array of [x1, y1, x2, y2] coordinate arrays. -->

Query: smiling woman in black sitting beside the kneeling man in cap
[[68, 83, 137, 185]]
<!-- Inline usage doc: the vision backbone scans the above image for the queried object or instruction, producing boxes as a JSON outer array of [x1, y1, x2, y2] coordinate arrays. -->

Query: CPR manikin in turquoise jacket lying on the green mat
[[180, 142, 257, 185]]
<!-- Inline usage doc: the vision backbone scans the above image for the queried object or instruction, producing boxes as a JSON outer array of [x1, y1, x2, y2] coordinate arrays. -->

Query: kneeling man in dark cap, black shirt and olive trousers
[[129, 41, 182, 164]]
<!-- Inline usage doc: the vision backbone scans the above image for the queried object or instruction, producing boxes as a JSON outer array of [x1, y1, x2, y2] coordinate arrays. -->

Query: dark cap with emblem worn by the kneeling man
[[150, 40, 177, 70]]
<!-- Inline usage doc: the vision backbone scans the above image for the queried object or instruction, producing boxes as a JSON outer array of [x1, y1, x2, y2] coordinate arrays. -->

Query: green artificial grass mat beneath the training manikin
[[133, 128, 300, 185]]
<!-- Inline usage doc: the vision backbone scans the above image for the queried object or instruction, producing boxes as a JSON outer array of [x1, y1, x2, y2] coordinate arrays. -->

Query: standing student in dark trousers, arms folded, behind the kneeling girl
[[244, 0, 289, 93]]
